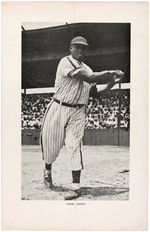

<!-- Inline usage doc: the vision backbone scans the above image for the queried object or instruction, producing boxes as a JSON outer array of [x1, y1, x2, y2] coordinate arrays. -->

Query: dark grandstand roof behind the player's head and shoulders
[[22, 23, 130, 88]]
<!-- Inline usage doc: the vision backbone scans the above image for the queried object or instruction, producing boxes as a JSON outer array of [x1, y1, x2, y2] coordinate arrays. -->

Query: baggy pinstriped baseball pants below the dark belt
[[41, 102, 85, 171]]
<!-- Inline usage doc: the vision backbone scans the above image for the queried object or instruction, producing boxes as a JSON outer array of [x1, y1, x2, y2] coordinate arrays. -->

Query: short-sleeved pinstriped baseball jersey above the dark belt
[[54, 55, 93, 105]]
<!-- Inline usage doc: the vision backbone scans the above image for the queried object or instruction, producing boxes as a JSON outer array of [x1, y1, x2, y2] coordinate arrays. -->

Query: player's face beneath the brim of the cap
[[70, 44, 87, 60]]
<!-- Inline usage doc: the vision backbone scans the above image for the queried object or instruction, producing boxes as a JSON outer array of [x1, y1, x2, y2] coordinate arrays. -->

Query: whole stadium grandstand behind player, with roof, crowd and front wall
[[21, 23, 130, 146]]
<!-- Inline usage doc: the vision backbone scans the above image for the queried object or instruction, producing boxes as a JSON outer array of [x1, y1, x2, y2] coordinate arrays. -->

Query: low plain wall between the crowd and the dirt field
[[21, 128, 130, 147]]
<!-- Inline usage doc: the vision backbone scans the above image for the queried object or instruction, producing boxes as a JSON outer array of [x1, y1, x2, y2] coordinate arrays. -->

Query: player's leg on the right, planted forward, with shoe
[[65, 108, 85, 200]]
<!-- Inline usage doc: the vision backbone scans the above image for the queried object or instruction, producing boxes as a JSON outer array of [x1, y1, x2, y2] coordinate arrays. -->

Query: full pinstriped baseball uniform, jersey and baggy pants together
[[41, 56, 93, 170]]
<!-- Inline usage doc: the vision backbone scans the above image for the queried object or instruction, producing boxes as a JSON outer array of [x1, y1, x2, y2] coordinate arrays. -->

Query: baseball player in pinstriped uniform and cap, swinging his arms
[[41, 36, 124, 200]]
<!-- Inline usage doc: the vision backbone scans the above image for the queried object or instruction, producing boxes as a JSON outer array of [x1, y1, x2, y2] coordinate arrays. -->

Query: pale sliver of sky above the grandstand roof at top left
[[21, 22, 70, 30]]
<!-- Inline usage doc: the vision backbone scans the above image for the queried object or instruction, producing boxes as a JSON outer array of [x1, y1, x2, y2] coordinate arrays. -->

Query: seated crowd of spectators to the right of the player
[[85, 90, 130, 129]]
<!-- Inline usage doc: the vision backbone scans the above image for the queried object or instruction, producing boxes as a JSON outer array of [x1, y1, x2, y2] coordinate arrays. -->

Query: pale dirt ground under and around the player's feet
[[21, 145, 130, 201]]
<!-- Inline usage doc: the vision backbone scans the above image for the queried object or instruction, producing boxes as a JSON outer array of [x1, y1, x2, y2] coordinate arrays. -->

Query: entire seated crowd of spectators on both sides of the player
[[21, 90, 130, 129]]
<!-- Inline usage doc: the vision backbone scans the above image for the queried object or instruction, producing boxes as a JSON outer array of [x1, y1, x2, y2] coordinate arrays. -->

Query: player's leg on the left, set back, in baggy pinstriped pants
[[41, 103, 65, 188]]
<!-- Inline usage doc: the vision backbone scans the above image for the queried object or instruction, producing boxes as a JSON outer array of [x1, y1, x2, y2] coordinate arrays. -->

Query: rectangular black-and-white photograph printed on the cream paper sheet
[[20, 22, 132, 202]]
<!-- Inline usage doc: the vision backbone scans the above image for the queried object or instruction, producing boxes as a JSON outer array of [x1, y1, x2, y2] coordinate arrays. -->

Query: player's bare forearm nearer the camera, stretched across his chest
[[72, 68, 117, 84]]
